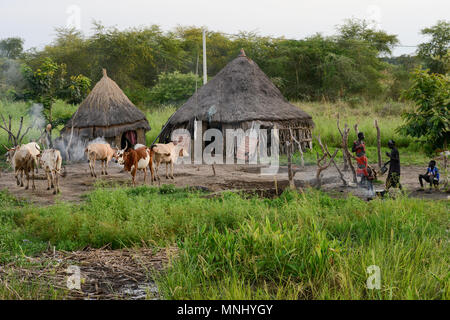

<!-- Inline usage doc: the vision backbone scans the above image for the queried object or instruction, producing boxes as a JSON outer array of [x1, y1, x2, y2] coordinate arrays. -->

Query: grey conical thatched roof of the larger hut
[[160, 50, 314, 152]]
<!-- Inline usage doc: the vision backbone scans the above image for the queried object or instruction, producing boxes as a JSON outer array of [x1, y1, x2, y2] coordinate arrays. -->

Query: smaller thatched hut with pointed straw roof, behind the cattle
[[61, 69, 150, 148]]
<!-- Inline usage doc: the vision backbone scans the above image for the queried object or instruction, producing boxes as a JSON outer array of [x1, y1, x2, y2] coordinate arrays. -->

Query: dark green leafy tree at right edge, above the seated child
[[398, 70, 450, 154]]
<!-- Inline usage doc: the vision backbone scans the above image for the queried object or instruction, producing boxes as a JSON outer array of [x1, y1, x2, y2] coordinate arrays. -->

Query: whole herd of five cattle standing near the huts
[[3, 141, 188, 194]]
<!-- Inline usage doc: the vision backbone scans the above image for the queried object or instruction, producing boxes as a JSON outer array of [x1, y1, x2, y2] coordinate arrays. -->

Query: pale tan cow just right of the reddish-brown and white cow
[[150, 141, 189, 180]]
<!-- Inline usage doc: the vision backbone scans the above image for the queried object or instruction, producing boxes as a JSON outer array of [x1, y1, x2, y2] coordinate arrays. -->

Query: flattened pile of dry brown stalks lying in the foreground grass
[[0, 247, 177, 299]]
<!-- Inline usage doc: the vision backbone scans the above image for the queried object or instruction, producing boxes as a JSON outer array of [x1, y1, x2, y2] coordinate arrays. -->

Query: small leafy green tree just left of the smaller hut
[[22, 58, 91, 134]]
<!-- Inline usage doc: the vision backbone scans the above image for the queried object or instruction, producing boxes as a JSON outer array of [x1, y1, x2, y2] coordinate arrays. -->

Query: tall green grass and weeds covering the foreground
[[0, 185, 450, 299]]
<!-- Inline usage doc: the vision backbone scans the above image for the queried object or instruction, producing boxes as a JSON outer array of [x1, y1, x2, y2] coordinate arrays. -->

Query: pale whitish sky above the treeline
[[0, 0, 450, 55]]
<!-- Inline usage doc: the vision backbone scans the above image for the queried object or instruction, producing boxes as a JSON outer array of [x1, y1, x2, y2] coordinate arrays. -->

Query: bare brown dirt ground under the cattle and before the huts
[[0, 162, 449, 205]]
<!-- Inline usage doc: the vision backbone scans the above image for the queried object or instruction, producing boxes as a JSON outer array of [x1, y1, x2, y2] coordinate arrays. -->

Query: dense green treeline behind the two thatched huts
[[0, 19, 449, 107]]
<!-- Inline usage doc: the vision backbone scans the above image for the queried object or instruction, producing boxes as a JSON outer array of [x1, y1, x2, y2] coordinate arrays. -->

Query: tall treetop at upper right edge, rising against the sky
[[417, 20, 450, 74]]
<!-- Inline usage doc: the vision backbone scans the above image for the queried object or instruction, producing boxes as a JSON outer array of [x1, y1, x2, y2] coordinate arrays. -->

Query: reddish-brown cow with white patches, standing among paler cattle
[[117, 146, 155, 186]]
